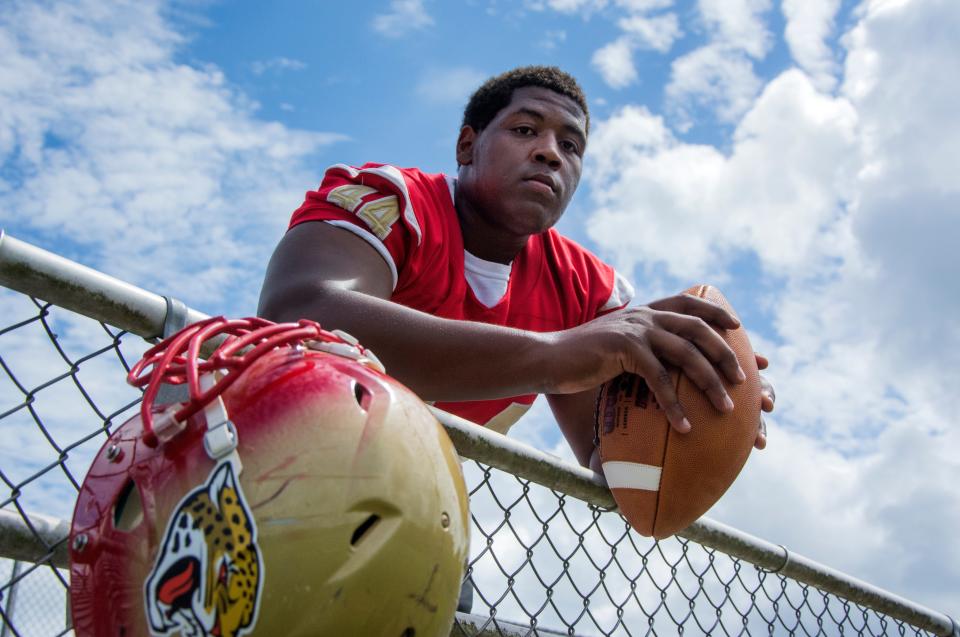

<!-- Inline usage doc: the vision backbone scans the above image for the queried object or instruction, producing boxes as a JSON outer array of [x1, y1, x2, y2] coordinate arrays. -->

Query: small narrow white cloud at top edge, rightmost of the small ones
[[783, 0, 840, 91]]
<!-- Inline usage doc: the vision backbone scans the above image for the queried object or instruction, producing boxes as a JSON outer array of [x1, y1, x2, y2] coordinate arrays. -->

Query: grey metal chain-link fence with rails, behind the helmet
[[0, 234, 958, 637]]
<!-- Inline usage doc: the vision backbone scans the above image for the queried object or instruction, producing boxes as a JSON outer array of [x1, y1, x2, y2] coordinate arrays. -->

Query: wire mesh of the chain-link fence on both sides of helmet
[[0, 288, 944, 637]]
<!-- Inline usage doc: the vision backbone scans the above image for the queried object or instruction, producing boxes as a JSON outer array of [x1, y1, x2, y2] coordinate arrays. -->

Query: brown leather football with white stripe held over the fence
[[597, 285, 760, 539]]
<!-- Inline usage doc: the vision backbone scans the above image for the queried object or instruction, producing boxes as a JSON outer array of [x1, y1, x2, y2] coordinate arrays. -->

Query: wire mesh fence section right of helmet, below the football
[[454, 462, 926, 635]]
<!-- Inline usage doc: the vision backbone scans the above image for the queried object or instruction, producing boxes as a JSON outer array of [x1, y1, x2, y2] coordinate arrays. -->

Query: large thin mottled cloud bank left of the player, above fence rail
[[0, 2, 342, 313]]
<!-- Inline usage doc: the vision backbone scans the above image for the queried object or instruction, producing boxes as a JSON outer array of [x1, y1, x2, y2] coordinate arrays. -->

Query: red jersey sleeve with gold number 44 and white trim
[[289, 164, 423, 289]]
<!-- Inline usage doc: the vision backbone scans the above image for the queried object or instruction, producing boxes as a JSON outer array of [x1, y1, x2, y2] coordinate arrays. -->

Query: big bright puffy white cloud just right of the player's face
[[587, 72, 856, 278]]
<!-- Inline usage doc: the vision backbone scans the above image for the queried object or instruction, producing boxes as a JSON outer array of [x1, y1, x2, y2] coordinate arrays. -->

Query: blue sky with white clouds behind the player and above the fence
[[0, 0, 960, 624]]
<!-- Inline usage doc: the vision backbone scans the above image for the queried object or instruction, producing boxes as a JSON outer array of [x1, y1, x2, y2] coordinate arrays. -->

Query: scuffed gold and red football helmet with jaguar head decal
[[70, 318, 469, 637]]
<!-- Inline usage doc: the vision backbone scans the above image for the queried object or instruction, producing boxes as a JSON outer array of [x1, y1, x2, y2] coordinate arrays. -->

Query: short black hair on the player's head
[[462, 66, 590, 132]]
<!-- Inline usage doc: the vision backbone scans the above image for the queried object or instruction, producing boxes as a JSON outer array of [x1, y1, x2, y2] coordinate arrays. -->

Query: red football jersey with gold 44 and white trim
[[290, 164, 633, 433]]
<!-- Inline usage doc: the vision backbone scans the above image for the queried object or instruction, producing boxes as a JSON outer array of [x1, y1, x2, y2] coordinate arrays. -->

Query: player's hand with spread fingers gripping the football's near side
[[552, 294, 746, 433]]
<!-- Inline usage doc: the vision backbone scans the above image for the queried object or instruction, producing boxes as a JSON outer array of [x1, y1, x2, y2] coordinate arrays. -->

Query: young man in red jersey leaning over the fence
[[259, 67, 773, 471]]
